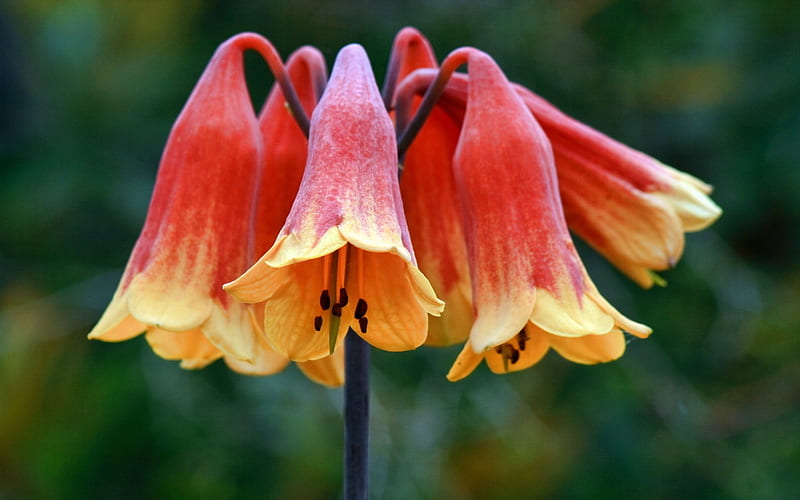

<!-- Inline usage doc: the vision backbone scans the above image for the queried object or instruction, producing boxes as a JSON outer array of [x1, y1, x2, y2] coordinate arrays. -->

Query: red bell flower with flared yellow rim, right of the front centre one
[[448, 50, 650, 380]]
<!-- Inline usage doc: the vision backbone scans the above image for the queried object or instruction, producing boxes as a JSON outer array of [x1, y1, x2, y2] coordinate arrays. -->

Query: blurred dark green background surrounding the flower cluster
[[0, 0, 800, 499]]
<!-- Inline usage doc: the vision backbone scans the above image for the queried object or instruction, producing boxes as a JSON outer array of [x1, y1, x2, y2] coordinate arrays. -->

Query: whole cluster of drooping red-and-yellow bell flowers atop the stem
[[89, 28, 721, 386]]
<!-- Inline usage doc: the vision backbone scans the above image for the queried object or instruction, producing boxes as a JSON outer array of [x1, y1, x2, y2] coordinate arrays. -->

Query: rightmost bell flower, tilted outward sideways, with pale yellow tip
[[517, 86, 722, 288]]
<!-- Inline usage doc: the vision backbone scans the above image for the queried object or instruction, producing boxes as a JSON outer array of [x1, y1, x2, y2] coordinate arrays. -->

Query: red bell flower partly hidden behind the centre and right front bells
[[389, 28, 472, 346]]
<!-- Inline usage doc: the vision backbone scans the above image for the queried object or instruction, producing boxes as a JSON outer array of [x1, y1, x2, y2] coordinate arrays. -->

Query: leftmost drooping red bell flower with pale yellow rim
[[89, 34, 286, 373]]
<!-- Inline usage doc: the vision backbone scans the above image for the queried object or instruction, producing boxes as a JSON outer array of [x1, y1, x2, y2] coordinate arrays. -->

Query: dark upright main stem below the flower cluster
[[343, 329, 369, 500]]
